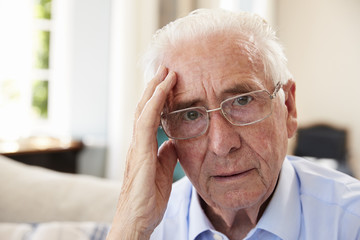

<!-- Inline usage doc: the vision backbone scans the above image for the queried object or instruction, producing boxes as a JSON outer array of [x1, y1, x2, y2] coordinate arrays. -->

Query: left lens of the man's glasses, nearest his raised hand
[[161, 107, 208, 139]]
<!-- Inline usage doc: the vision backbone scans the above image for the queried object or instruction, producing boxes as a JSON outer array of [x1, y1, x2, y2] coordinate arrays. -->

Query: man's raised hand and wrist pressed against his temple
[[107, 66, 177, 240]]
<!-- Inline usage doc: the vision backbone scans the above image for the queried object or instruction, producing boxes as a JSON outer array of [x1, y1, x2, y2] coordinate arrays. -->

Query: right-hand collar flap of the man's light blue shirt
[[248, 158, 301, 239]]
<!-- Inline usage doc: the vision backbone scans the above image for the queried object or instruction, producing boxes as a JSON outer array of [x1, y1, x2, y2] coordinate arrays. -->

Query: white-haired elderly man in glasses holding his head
[[108, 10, 360, 240]]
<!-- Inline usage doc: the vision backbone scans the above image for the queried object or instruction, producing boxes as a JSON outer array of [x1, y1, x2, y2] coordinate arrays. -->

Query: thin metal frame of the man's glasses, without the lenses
[[160, 82, 282, 140]]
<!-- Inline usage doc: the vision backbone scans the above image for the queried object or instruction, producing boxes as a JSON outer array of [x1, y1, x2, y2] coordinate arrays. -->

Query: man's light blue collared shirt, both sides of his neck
[[151, 156, 360, 240]]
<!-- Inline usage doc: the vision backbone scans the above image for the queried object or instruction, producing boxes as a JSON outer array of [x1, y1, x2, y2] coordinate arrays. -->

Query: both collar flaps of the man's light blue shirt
[[189, 158, 301, 239]]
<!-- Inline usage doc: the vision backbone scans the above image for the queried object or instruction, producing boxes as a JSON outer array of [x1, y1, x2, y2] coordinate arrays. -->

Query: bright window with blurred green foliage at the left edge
[[0, 0, 52, 140]]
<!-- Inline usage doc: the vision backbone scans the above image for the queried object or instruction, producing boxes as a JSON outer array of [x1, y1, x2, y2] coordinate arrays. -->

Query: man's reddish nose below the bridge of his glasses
[[208, 111, 241, 157]]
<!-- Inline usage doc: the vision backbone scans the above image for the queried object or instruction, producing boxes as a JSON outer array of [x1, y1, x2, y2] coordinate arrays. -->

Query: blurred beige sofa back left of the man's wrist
[[0, 156, 121, 223]]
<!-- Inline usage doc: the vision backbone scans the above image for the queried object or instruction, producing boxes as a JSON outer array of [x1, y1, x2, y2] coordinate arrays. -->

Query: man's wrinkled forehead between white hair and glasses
[[165, 35, 266, 108]]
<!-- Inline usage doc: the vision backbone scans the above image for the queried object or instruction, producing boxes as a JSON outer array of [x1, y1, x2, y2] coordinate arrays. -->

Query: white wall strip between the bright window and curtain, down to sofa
[[49, 0, 111, 176]]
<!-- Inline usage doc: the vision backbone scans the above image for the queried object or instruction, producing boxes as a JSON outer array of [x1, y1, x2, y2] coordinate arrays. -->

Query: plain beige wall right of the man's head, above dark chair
[[277, 0, 360, 177]]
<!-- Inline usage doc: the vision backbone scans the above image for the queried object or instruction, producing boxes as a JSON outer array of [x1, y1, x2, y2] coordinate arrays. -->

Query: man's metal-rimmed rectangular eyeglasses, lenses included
[[161, 82, 282, 139]]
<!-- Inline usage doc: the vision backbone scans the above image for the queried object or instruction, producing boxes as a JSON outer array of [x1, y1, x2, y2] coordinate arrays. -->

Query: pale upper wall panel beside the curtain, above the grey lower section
[[71, 0, 110, 139]]
